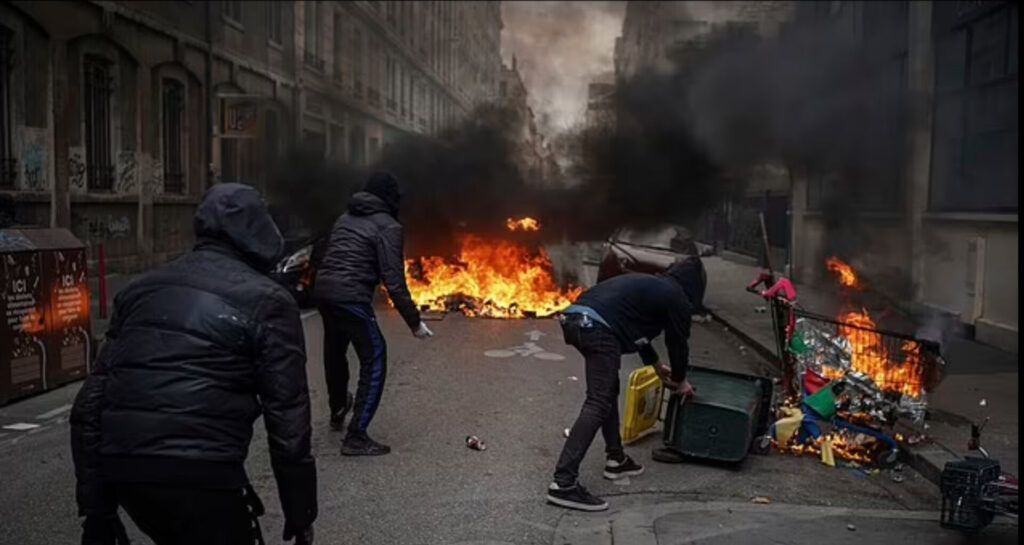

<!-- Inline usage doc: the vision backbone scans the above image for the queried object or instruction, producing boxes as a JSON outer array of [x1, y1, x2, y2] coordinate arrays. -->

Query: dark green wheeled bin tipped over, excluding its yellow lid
[[664, 367, 772, 462]]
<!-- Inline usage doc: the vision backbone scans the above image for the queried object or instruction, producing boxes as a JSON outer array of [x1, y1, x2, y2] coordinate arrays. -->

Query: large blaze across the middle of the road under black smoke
[[406, 217, 583, 319]]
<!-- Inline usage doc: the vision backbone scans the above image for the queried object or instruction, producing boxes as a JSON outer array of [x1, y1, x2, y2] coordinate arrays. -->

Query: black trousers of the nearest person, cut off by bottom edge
[[115, 485, 263, 545]]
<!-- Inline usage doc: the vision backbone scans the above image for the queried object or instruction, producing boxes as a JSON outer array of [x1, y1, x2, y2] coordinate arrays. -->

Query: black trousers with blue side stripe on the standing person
[[319, 303, 387, 433]]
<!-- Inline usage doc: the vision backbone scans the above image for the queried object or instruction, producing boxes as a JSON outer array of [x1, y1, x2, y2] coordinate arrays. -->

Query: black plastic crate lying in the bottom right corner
[[940, 458, 999, 531]]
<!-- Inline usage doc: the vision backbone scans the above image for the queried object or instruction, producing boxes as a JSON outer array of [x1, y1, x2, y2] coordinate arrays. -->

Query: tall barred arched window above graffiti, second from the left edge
[[82, 55, 114, 191]]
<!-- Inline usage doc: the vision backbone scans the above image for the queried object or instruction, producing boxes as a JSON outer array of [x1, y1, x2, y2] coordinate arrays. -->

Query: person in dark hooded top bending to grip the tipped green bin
[[547, 258, 703, 511]]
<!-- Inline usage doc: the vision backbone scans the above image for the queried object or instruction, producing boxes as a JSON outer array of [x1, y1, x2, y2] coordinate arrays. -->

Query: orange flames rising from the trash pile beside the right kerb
[[823, 257, 925, 397]]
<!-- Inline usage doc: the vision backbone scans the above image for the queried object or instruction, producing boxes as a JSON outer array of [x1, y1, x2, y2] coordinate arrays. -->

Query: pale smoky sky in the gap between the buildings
[[502, 2, 626, 134]]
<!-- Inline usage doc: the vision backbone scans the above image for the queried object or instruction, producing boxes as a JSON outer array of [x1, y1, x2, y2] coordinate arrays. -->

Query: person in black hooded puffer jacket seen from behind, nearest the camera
[[71, 183, 316, 545]]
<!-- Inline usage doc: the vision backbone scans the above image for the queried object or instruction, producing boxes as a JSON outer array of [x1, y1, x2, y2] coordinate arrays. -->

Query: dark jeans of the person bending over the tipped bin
[[555, 315, 624, 487]]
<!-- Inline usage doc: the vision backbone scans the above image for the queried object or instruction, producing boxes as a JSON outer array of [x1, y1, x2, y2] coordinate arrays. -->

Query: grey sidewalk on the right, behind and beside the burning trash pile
[[705, 257, 1018, 481]]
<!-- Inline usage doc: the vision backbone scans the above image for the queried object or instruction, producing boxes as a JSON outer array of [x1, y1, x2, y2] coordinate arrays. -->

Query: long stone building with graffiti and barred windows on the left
[[0, 0, 502, 270]]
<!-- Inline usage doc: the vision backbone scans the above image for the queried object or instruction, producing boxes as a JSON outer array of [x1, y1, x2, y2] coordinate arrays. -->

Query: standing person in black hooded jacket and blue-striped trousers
[[313, 172, 433, 456]]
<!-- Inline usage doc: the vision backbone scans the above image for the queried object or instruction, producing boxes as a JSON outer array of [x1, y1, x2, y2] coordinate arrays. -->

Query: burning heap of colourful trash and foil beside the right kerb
[[771, 257, 944, 469]]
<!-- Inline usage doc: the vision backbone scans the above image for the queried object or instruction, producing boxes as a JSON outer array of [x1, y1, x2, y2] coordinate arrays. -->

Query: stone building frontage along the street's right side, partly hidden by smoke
[[615, 1, 1020, 352]]
